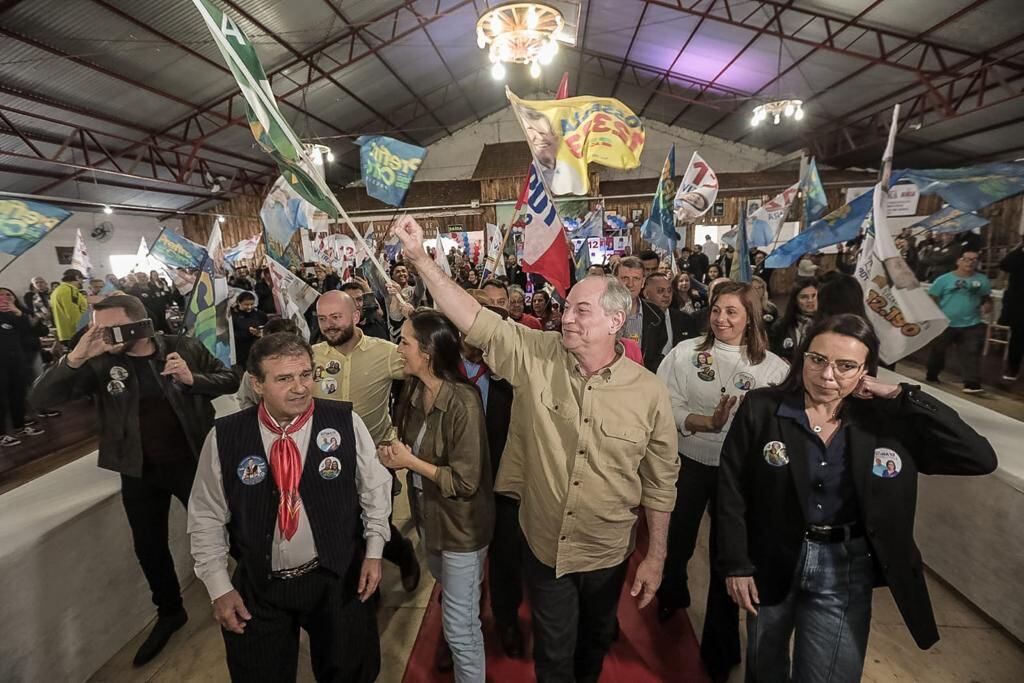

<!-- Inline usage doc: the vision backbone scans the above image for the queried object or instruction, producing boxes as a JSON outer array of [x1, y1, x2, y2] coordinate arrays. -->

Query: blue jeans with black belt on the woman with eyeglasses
[[746, 538, 874, 683]]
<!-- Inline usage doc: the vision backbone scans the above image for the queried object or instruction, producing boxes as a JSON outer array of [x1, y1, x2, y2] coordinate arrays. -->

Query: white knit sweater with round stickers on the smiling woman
[[657, 337, 790, 467]]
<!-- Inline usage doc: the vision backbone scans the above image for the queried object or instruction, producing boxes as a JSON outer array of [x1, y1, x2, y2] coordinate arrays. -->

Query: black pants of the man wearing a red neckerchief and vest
[[221, 561, 381, 683]]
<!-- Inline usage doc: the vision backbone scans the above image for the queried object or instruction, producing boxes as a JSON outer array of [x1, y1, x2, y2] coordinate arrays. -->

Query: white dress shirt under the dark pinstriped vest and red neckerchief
[[188, 413, 391, 600]]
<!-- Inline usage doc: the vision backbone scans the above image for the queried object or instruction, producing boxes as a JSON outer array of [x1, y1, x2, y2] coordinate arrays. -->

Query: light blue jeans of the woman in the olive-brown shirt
[[421, 540, 487, 683]]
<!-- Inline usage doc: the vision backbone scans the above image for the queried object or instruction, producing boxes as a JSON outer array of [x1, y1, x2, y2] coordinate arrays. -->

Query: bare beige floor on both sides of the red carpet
[[90, 481, 1024, 683]]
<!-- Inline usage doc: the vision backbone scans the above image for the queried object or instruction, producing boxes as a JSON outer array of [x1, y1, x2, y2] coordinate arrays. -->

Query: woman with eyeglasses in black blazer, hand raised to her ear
[[717, 313, 996, 683]]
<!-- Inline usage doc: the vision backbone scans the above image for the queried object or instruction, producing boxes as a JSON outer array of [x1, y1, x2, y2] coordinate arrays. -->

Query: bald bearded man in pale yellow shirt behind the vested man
[[313, 290, 420, 592]]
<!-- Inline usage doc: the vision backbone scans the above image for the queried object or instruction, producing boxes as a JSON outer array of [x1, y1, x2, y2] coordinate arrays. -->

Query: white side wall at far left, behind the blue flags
[[0, 211, 181, 294]]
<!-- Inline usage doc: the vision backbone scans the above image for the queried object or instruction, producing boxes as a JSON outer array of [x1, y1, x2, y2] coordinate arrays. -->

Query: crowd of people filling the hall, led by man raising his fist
[[6, 217, 1024, 683]]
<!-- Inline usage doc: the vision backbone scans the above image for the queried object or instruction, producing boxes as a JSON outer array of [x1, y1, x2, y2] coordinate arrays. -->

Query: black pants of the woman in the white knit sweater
[[657, 456, 740, 676]]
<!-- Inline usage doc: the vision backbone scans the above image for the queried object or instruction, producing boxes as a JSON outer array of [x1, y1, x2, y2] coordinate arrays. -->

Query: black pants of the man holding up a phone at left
[[121, 460, 196, 616]]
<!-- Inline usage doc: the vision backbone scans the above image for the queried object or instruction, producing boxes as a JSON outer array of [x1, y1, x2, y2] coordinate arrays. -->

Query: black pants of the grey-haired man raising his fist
[[523, 543, 626, 683]]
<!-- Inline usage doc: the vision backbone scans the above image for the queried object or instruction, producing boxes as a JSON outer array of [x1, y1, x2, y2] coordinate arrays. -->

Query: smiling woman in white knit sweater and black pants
[[657, 282, 788, 680]]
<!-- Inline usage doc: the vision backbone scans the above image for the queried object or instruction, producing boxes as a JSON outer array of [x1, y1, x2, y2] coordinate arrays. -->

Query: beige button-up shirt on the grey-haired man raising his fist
[[466, 309, 679, 577]]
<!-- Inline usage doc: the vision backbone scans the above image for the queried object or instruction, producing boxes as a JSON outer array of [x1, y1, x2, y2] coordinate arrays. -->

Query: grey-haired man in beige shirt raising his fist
[[395, 216, 679, 683]]
